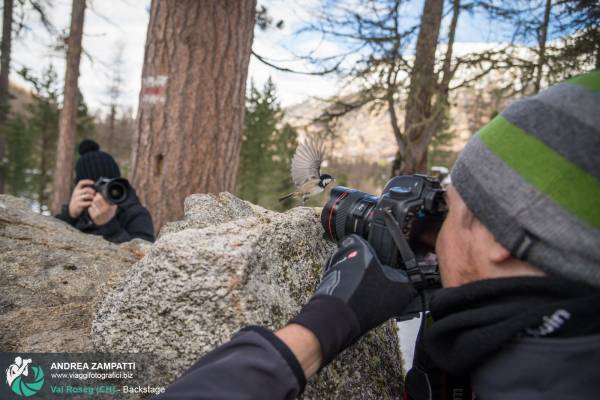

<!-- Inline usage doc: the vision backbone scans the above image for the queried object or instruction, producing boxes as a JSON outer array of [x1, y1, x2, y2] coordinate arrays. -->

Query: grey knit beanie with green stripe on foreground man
[[452, 71, 600, 287]]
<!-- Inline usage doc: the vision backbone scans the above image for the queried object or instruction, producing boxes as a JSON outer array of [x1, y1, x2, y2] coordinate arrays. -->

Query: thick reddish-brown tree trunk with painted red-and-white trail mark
[[130, 0, 256, 231]]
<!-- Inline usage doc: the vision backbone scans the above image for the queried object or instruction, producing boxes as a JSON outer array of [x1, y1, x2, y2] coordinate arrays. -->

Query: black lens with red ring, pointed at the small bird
[[321, 186, 379, 242]]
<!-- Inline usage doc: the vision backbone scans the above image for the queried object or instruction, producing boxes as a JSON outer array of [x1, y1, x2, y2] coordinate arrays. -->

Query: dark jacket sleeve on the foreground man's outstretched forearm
[[153, 326, 306, 400]]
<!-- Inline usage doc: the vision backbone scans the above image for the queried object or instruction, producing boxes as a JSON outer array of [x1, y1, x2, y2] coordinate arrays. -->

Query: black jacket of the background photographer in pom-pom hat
[[55, 192, 154, 243]]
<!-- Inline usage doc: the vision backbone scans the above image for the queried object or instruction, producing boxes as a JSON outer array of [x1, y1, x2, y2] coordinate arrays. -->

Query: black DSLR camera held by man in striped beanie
[[321, 175, 447, 319]]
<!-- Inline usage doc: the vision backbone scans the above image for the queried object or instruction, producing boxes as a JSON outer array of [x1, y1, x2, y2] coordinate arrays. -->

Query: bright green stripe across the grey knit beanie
[[478, 115, 600, 229]]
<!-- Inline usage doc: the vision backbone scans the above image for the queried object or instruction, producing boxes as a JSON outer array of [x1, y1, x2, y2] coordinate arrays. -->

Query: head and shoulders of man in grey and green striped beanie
[[418, 71, 600, 399]]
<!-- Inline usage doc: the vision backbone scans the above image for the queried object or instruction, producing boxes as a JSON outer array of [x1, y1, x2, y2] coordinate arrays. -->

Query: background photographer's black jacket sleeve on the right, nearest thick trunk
[[98, 207, 154, 243]]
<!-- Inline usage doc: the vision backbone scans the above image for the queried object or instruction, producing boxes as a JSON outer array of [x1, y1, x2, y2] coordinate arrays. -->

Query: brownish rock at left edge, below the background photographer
[[0, 195, 149, 352]]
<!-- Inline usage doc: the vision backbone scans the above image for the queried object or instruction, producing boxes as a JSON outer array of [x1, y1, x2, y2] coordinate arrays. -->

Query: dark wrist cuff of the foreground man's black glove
[[289, 295, 361, 368]]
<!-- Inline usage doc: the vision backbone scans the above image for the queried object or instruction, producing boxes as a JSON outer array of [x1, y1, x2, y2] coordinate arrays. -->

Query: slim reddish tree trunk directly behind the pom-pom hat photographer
[[51, 0, 85, 213]]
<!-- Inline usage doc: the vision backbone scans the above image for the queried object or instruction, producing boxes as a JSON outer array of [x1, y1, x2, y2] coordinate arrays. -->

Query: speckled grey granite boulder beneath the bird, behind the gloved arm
[[92, 193, 402, 399]]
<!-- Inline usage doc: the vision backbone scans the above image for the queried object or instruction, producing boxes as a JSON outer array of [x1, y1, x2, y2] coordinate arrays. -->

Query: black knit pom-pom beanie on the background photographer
[[75, 139, 121, 184]]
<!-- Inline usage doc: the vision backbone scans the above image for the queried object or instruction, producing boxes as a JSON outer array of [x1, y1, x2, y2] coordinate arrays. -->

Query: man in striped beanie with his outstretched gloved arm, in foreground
[[152, 71, 600, 400]]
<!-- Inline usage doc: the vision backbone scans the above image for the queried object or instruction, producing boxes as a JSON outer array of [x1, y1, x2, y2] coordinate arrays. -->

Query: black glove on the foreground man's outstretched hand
[[290, 235, 418, 367]]
